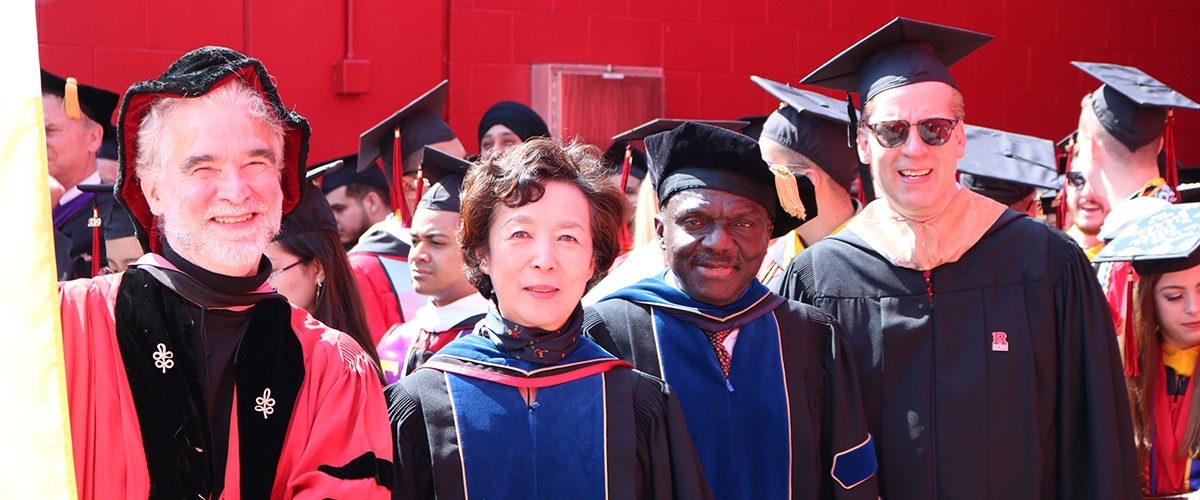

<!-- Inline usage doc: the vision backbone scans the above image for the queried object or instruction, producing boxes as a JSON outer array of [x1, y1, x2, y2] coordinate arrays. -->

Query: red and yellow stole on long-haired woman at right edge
[[1151, 344, 1195, 494]]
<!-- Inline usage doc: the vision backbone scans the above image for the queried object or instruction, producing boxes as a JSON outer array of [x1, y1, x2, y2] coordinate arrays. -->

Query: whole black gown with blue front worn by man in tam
[[587, 276, 878, 499]]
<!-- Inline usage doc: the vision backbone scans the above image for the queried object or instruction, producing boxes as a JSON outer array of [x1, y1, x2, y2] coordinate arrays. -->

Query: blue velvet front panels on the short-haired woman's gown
[[446, 369, 607, 500]]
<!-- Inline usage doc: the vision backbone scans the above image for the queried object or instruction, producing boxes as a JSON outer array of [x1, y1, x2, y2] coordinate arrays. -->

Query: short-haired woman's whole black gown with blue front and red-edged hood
[[386, 335, 712, 500]]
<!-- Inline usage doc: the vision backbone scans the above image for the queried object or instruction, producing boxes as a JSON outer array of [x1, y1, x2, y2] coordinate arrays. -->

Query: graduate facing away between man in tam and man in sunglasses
[[750, 76, 863, 289]]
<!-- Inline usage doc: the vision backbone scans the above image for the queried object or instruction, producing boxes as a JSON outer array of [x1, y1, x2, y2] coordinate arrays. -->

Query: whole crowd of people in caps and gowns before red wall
[[42, 13, 1200, 499]]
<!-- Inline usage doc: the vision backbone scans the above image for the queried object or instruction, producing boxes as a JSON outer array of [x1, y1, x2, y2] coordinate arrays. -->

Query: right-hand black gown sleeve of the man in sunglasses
[[1055, 246, 1141, 499]]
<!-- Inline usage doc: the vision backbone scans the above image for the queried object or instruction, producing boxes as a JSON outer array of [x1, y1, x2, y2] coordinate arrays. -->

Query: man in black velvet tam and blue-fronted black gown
[[588, 122, 878, 499]]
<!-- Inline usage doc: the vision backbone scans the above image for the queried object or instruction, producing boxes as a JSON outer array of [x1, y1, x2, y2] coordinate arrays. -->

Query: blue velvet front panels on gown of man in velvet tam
[[654, 305, 792, 499]]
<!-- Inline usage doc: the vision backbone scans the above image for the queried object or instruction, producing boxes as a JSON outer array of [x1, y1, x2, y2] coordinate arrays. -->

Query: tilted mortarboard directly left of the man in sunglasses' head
[[750, 76, 859, 191]]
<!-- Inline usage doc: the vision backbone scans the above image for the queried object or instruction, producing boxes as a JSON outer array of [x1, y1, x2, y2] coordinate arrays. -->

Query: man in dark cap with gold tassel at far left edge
[[42, 70, 120, 279]]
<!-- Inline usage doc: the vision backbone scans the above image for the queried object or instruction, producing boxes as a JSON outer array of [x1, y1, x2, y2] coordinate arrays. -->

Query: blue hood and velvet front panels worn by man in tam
[[613, 276, 792, 499]]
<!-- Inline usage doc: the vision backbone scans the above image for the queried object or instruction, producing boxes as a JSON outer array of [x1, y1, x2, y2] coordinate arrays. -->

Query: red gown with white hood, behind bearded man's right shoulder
[[346, 218, 425, 345]]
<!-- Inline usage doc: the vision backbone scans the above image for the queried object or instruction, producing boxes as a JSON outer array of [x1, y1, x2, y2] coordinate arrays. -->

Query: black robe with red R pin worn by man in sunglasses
[[780, 211, 1141, 500]]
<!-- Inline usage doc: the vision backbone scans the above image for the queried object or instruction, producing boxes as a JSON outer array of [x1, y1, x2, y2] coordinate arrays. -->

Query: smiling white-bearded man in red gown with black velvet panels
[[59, 47, 392, 499]]
